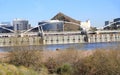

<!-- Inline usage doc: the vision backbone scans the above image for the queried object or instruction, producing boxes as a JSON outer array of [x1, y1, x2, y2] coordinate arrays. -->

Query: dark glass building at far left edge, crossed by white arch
[[0, 22, 13, 33]]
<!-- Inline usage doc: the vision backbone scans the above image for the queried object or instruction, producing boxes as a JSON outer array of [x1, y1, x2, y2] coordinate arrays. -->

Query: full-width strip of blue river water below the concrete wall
[[0, 42, 120, 52]]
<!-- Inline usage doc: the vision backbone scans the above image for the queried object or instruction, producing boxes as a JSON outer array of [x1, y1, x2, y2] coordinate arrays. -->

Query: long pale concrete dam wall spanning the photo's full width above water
[[0, 34, 120, 47]]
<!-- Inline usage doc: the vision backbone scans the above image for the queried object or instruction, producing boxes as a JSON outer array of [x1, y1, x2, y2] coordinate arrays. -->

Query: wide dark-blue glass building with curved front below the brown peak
[[38, 20, 64, 32]]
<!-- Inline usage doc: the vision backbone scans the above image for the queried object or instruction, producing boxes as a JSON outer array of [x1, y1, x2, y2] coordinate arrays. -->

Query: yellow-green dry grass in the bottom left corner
[[0, 63, 39, 75]]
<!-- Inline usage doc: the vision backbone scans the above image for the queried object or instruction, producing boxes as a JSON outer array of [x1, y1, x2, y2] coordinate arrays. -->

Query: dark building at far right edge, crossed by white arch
[[103, 18, 120, 30]]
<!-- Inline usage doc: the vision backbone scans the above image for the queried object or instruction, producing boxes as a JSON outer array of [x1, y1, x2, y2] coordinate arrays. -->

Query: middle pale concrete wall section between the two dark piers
[[43, 35, 85, 44]]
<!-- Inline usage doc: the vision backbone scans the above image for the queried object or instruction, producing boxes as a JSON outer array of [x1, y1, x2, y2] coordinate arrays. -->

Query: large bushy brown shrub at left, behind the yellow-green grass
[[9, 50, 41, 70]]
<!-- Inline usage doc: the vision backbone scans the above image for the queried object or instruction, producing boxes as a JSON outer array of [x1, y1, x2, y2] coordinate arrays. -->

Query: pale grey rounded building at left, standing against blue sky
[[13, 19, 30, 32]]
